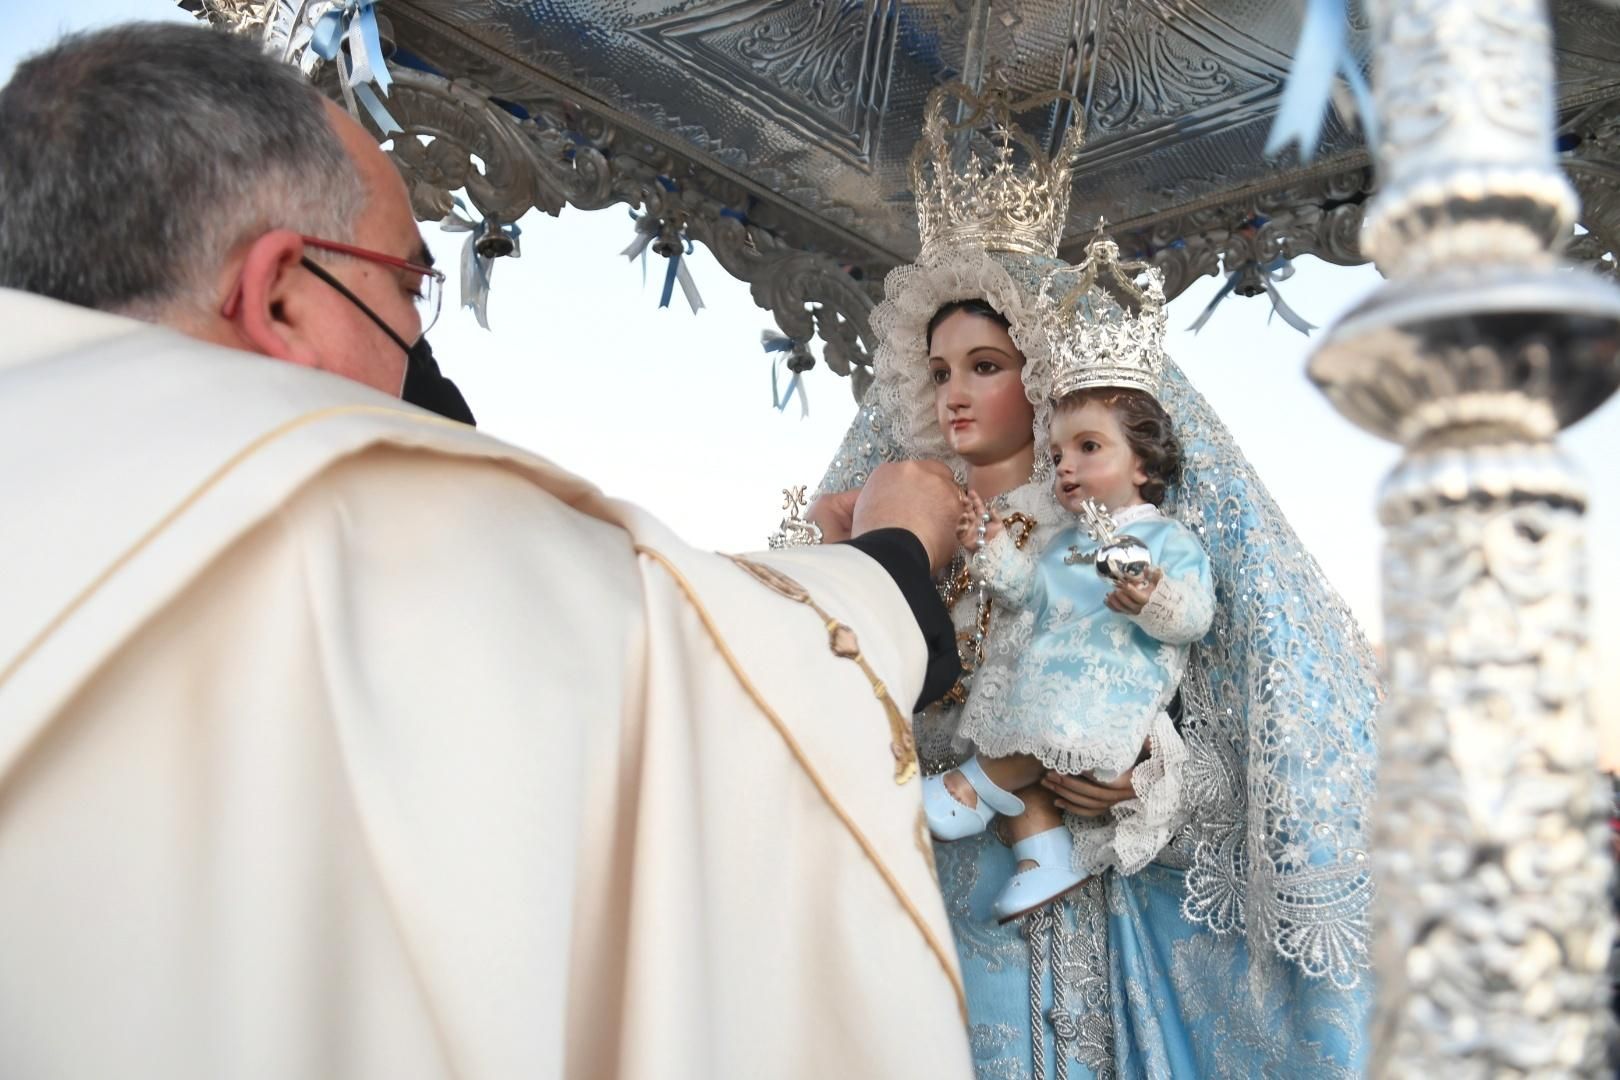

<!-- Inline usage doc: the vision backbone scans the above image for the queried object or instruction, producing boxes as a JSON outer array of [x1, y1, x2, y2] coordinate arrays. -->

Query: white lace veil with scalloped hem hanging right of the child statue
[[1160, 364, 1380, 988]]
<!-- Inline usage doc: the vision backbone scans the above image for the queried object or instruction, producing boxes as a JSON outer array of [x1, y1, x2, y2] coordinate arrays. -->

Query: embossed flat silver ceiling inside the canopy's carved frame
[[384, 0, 1380, 262]]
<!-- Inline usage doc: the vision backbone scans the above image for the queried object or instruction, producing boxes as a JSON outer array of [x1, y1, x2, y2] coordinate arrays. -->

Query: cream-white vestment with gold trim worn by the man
[[0, 290, 970, 1080]]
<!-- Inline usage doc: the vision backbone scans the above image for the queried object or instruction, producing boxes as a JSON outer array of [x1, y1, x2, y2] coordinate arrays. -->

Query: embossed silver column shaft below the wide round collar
[[1374, 444, 1614, 1077]]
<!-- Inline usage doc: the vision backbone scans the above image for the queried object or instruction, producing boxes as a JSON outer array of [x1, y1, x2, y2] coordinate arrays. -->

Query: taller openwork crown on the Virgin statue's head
[[910, 83, 1082, 257]]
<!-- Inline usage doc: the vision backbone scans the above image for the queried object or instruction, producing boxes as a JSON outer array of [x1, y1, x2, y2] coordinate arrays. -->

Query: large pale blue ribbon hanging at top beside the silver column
[[1265, 0, 1379, 162]]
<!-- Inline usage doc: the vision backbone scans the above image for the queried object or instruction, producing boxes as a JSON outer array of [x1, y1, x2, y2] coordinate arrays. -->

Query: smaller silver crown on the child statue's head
[[1037, 230, 1165, 398]]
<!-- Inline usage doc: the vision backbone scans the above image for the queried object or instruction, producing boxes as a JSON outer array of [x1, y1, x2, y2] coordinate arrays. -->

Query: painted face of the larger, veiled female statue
[[928, 311, 1035, 466]]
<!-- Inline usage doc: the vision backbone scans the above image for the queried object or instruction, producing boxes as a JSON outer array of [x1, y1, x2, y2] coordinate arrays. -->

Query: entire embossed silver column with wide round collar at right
[[1311, 0, 1620, 1080]]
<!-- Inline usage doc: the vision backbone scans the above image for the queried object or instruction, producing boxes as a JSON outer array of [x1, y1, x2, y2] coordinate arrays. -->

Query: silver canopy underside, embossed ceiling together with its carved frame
[[192, 0, 1620, 295]]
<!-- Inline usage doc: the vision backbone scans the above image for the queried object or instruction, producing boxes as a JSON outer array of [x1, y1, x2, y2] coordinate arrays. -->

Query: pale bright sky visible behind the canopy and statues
[[0, 0, 1620, 764]]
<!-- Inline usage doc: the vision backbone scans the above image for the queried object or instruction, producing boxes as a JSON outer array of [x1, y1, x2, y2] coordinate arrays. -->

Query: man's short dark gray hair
[[0, 23, 366, 319]]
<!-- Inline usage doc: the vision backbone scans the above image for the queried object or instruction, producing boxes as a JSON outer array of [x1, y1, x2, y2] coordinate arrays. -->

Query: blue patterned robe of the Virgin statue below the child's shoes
[[935, 832, 1371, 1080]]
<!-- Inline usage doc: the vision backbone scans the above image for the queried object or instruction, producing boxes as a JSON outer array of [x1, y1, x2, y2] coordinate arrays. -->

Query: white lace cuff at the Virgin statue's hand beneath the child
[[1066, 712, 1187, 874]]
